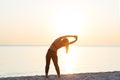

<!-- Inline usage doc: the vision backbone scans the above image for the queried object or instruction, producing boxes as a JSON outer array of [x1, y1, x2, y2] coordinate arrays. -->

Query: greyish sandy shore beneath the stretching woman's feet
[[0, 71, 120, 80]]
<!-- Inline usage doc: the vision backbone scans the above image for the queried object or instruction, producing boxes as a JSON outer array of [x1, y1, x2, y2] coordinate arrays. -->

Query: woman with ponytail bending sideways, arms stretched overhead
[[45, 35, 77, 78]]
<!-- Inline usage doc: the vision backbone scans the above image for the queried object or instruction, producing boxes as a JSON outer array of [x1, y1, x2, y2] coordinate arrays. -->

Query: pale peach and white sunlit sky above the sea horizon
[[0, 0, 120, 45]]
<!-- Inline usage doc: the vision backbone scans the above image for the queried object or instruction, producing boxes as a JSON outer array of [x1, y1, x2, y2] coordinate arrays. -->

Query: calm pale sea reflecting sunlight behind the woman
[[0, 46, 120, 77]]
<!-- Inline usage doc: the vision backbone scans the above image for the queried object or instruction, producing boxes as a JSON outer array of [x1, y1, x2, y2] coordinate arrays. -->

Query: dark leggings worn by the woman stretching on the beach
[[45, 49, 60, 76]]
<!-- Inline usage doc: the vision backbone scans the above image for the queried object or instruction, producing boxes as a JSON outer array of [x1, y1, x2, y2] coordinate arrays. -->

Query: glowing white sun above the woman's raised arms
[[54, 11, 84, 35]]
